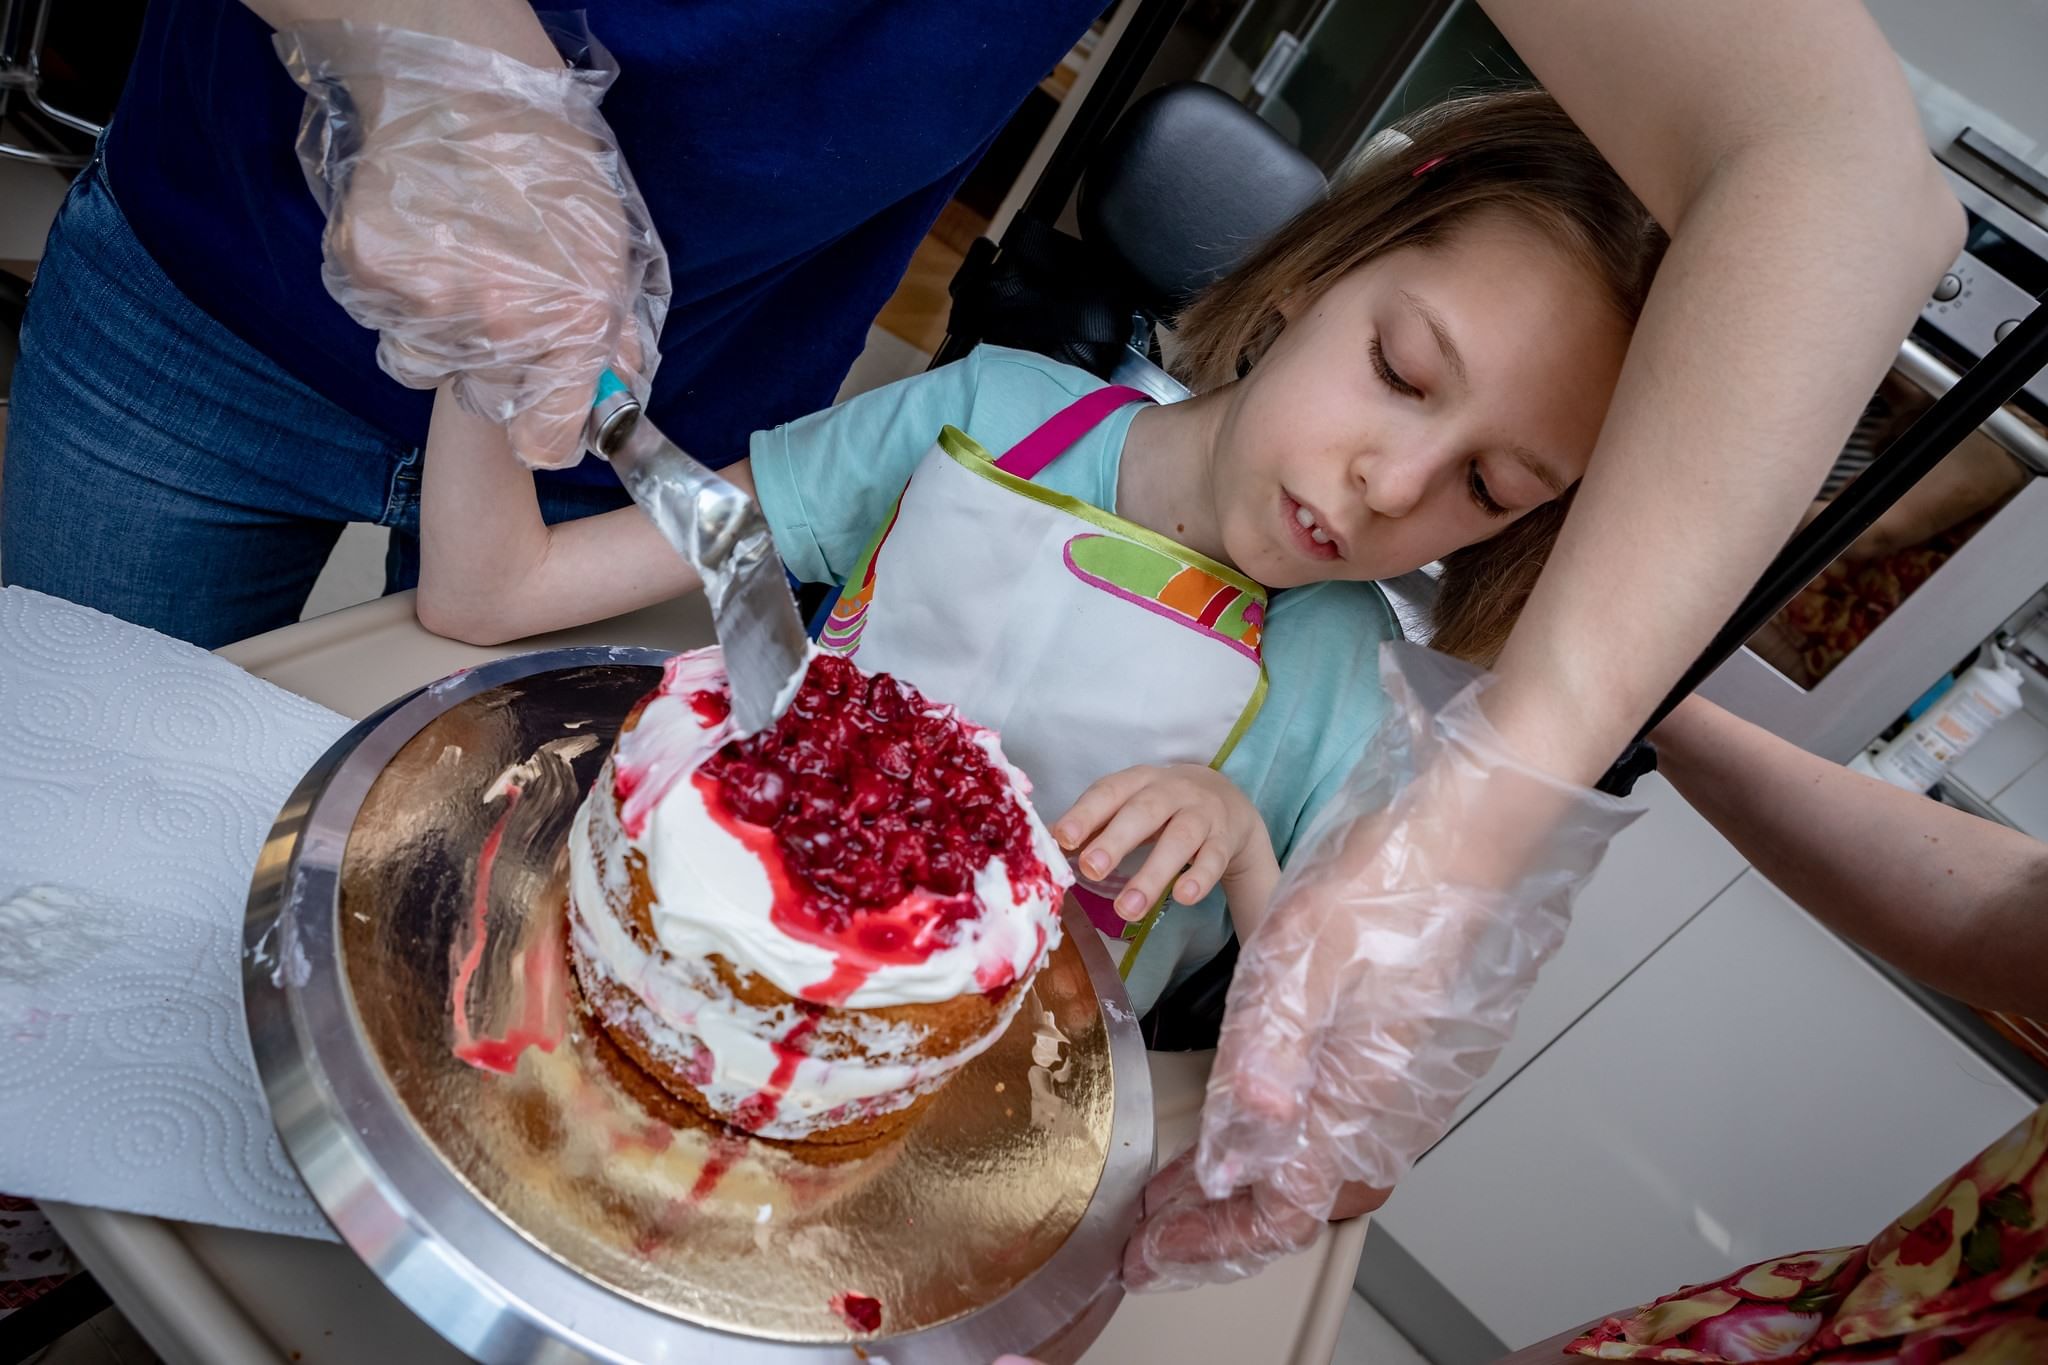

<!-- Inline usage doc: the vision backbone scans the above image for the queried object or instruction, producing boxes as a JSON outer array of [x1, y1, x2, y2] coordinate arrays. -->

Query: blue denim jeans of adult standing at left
[[0, 144, 627, 649]]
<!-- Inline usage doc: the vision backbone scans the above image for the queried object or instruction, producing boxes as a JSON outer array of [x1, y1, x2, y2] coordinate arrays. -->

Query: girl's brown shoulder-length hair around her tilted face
[[1174, 90, 1665, 663]]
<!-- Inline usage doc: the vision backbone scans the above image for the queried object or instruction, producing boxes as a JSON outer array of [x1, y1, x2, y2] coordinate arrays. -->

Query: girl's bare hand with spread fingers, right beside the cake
[[1053, 763, 1280, 921]]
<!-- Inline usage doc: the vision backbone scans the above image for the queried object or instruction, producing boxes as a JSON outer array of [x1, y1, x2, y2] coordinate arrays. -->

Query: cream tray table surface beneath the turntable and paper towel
[[45, 593, 1366, 1365]]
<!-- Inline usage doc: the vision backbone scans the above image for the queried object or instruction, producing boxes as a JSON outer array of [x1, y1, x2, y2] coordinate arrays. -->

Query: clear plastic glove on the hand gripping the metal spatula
[[276, 23, 670, 467]]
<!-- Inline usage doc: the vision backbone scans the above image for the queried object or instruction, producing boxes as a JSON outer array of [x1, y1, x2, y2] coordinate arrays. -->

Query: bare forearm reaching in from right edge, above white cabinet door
[[1655, 698, 2048, 1015]]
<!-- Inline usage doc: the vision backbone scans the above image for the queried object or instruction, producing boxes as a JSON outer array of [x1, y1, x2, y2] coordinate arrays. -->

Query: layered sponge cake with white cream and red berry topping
[[569, 649, 1071, 1154]]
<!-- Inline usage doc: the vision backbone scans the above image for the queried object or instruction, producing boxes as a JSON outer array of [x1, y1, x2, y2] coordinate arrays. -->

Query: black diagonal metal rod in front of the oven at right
[[1636, 293, 2048, 739]]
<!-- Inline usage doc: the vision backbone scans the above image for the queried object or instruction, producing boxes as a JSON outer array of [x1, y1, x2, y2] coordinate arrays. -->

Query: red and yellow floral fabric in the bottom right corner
[[1569, 1105, 2048, 1365]]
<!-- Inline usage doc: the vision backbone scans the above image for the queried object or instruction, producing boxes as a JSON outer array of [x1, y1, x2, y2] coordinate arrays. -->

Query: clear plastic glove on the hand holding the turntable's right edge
[[1124, 645, 1638, 1289]]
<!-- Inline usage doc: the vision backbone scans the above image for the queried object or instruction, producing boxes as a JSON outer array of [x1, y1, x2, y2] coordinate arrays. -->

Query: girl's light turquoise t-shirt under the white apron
[[752, 346, 1401, 1013]]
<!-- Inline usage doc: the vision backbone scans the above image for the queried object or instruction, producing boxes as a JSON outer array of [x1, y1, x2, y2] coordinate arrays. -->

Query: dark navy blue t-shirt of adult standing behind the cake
[[106, 0, 1104, 481]]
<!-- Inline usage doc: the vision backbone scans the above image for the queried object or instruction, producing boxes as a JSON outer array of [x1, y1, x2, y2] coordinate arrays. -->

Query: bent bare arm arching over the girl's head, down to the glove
[[1487, 0, 1962, 780]]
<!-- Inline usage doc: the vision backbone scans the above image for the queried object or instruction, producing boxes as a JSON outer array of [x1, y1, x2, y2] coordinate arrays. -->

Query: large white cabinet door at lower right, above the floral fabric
[[1374, 872, 2032, 1347]]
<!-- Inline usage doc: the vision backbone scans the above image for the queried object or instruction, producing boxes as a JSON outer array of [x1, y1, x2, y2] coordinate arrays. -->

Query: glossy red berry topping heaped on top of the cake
[[692, 655, 1051, 1005]]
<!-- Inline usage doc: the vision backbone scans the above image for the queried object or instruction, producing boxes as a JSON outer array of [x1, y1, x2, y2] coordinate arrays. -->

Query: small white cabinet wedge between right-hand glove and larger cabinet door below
[[1462, 776, 1745, 1113]]
